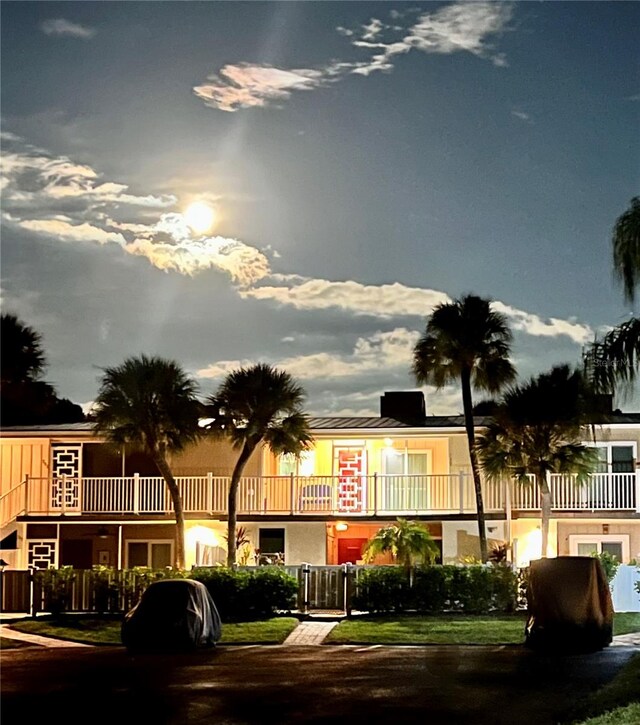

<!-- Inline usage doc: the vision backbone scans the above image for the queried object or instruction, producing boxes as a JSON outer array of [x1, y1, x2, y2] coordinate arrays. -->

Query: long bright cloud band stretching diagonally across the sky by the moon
[[2, 139, 593, 350]]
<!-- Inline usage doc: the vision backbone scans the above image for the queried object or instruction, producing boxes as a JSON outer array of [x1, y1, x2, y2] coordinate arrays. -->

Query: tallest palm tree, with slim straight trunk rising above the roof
[[413, 295, 515, 562]]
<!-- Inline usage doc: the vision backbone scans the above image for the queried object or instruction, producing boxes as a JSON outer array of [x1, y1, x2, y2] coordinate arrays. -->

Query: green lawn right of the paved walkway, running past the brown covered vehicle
[[326, 613, 640, 644]]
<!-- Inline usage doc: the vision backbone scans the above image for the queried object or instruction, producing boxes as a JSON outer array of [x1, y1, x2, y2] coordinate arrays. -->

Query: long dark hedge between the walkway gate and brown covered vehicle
[[353, 565, 518, 614]]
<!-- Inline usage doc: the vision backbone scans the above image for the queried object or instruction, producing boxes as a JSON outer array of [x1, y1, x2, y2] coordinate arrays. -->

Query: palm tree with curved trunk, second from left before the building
[[209, 363, 313, 567]]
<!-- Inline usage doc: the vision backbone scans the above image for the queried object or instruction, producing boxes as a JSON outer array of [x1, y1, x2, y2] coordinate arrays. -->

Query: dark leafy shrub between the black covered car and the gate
[[191, 566, 298, 621]]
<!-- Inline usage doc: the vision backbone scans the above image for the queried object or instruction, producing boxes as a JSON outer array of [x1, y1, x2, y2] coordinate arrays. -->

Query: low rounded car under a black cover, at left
[[122, 579, 222, 652]]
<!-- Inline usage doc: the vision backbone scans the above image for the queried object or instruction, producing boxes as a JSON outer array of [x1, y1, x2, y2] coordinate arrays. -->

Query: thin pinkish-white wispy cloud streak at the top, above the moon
[[193, 1, 513, 112]]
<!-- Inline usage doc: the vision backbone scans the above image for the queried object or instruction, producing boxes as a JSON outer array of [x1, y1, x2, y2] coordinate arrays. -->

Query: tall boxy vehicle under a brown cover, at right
[[525, 556, 613, 652]]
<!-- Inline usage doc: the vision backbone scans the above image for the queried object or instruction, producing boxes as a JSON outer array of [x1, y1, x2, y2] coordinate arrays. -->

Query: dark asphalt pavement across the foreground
[[2, 646, 633, 725]]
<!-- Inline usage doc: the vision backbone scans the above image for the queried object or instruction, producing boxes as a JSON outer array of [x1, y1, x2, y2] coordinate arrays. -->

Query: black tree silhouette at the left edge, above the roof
[[0, 313, 84, 426]]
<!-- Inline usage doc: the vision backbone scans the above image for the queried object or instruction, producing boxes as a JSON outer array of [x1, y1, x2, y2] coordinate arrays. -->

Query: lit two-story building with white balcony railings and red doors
[[0, 393, 640, 568]]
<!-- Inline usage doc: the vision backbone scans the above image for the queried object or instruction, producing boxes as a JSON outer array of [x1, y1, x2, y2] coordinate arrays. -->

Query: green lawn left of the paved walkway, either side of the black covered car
[[11, 616, 298, 645]]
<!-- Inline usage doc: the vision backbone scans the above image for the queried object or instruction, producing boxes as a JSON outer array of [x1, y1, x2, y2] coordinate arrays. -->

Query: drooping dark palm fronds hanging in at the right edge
[[585, 196, 640, 393]]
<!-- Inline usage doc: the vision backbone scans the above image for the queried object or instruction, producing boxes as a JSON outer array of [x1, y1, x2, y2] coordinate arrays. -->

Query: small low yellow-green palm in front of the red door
[[362, 519, 440, 569]]
